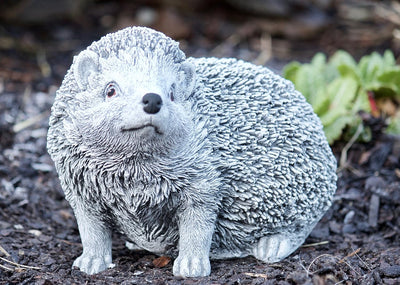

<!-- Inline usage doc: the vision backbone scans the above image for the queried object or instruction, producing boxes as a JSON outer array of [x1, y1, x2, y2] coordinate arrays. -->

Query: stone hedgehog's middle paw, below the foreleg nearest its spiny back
[[173, 255, 211, 277]]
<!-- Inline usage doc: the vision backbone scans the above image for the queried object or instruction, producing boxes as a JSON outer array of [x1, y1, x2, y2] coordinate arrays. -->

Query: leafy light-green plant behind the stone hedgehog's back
[[283, 50, 400, 144]]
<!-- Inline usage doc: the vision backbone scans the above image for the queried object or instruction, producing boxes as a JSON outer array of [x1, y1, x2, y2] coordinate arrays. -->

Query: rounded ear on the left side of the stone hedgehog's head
[[74, 50, 99, 90]]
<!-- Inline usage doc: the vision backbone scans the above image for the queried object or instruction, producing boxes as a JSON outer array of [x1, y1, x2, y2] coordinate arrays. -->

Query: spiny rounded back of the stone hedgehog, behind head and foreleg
[[190, 58, 336, 250]]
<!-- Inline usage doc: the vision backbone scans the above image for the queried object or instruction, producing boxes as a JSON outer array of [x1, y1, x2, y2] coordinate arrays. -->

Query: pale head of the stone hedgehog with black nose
[[55, 27, 195, 158]]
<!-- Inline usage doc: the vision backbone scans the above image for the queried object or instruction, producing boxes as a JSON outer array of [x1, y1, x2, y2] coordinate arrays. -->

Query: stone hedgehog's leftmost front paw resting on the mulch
[[72, 253, 114, 274]]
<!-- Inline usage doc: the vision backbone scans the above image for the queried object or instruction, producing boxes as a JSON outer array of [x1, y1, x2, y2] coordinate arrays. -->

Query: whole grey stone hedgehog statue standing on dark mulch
[[48, 27, 336, 277]]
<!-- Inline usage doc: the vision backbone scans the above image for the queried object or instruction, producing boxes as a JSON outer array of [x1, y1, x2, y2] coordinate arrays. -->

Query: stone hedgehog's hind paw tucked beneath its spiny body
[[252, 234, 304, 263]]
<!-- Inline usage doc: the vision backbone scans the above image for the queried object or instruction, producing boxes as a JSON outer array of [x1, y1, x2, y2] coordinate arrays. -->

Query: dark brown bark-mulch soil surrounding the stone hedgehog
[[0, 1, 400, 284]]
